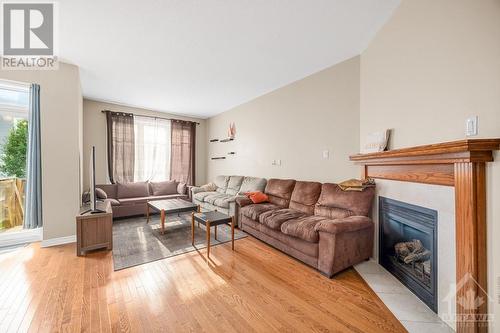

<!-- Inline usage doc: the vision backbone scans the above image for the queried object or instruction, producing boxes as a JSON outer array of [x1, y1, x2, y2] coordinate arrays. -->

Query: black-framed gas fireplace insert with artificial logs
[[379, 197, 437, 312]]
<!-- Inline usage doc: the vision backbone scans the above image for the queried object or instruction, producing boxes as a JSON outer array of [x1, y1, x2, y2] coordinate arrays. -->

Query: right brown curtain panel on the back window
[[170, 120, 196, 185]]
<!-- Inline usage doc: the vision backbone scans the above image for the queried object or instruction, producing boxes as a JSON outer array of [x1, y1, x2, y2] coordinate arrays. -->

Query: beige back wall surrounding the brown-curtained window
[[83, 99, 207, 188]]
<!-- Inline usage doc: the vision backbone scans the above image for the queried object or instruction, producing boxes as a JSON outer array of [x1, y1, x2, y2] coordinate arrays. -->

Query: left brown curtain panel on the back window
[[106, 111, 135, 184]]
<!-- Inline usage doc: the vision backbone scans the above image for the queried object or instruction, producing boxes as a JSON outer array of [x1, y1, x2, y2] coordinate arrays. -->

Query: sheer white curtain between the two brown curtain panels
[[134, 116, 171, 181]]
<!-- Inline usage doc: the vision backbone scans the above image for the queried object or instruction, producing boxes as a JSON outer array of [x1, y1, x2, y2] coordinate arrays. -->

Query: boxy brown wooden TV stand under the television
[[76, 202, 113, 256]]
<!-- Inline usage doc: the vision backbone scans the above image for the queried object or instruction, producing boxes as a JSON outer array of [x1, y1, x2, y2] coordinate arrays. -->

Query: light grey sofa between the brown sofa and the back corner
[[191, 176, 267, 219]]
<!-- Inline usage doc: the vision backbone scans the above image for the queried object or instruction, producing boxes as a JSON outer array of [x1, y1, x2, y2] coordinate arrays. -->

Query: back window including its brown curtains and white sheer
[[105, 110, 196, 185]]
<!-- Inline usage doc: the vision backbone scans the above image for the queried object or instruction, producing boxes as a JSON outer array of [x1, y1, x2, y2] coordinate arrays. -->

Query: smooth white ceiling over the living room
[[59, 0, 400, 118]]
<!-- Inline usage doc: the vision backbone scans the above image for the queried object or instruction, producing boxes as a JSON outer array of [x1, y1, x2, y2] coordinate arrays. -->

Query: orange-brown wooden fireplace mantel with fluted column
[[350, 139, 500, 332]]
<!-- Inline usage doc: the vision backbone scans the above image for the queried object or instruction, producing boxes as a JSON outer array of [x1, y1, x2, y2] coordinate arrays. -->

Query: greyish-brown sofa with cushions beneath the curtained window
[[96, 181, 188, 218]]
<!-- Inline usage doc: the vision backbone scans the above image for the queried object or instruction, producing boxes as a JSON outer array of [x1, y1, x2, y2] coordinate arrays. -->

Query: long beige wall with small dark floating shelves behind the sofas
[[207, 57, 359, 182]]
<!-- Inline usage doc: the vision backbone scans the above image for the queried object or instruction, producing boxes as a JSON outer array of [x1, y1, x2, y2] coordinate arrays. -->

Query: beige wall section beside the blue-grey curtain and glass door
[[0, 63, 82, 240]]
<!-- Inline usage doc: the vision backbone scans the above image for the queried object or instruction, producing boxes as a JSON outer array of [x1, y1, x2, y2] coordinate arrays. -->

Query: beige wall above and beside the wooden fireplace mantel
[[360, 0, 500, 332]]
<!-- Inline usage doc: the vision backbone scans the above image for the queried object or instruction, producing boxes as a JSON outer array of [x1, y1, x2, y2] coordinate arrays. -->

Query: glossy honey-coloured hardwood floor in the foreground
[[0, 237, 405, 333]]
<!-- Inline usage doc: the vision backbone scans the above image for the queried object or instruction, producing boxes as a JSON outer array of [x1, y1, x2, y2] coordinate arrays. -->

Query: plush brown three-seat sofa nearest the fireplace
[[237, 179, 374, 277]]
